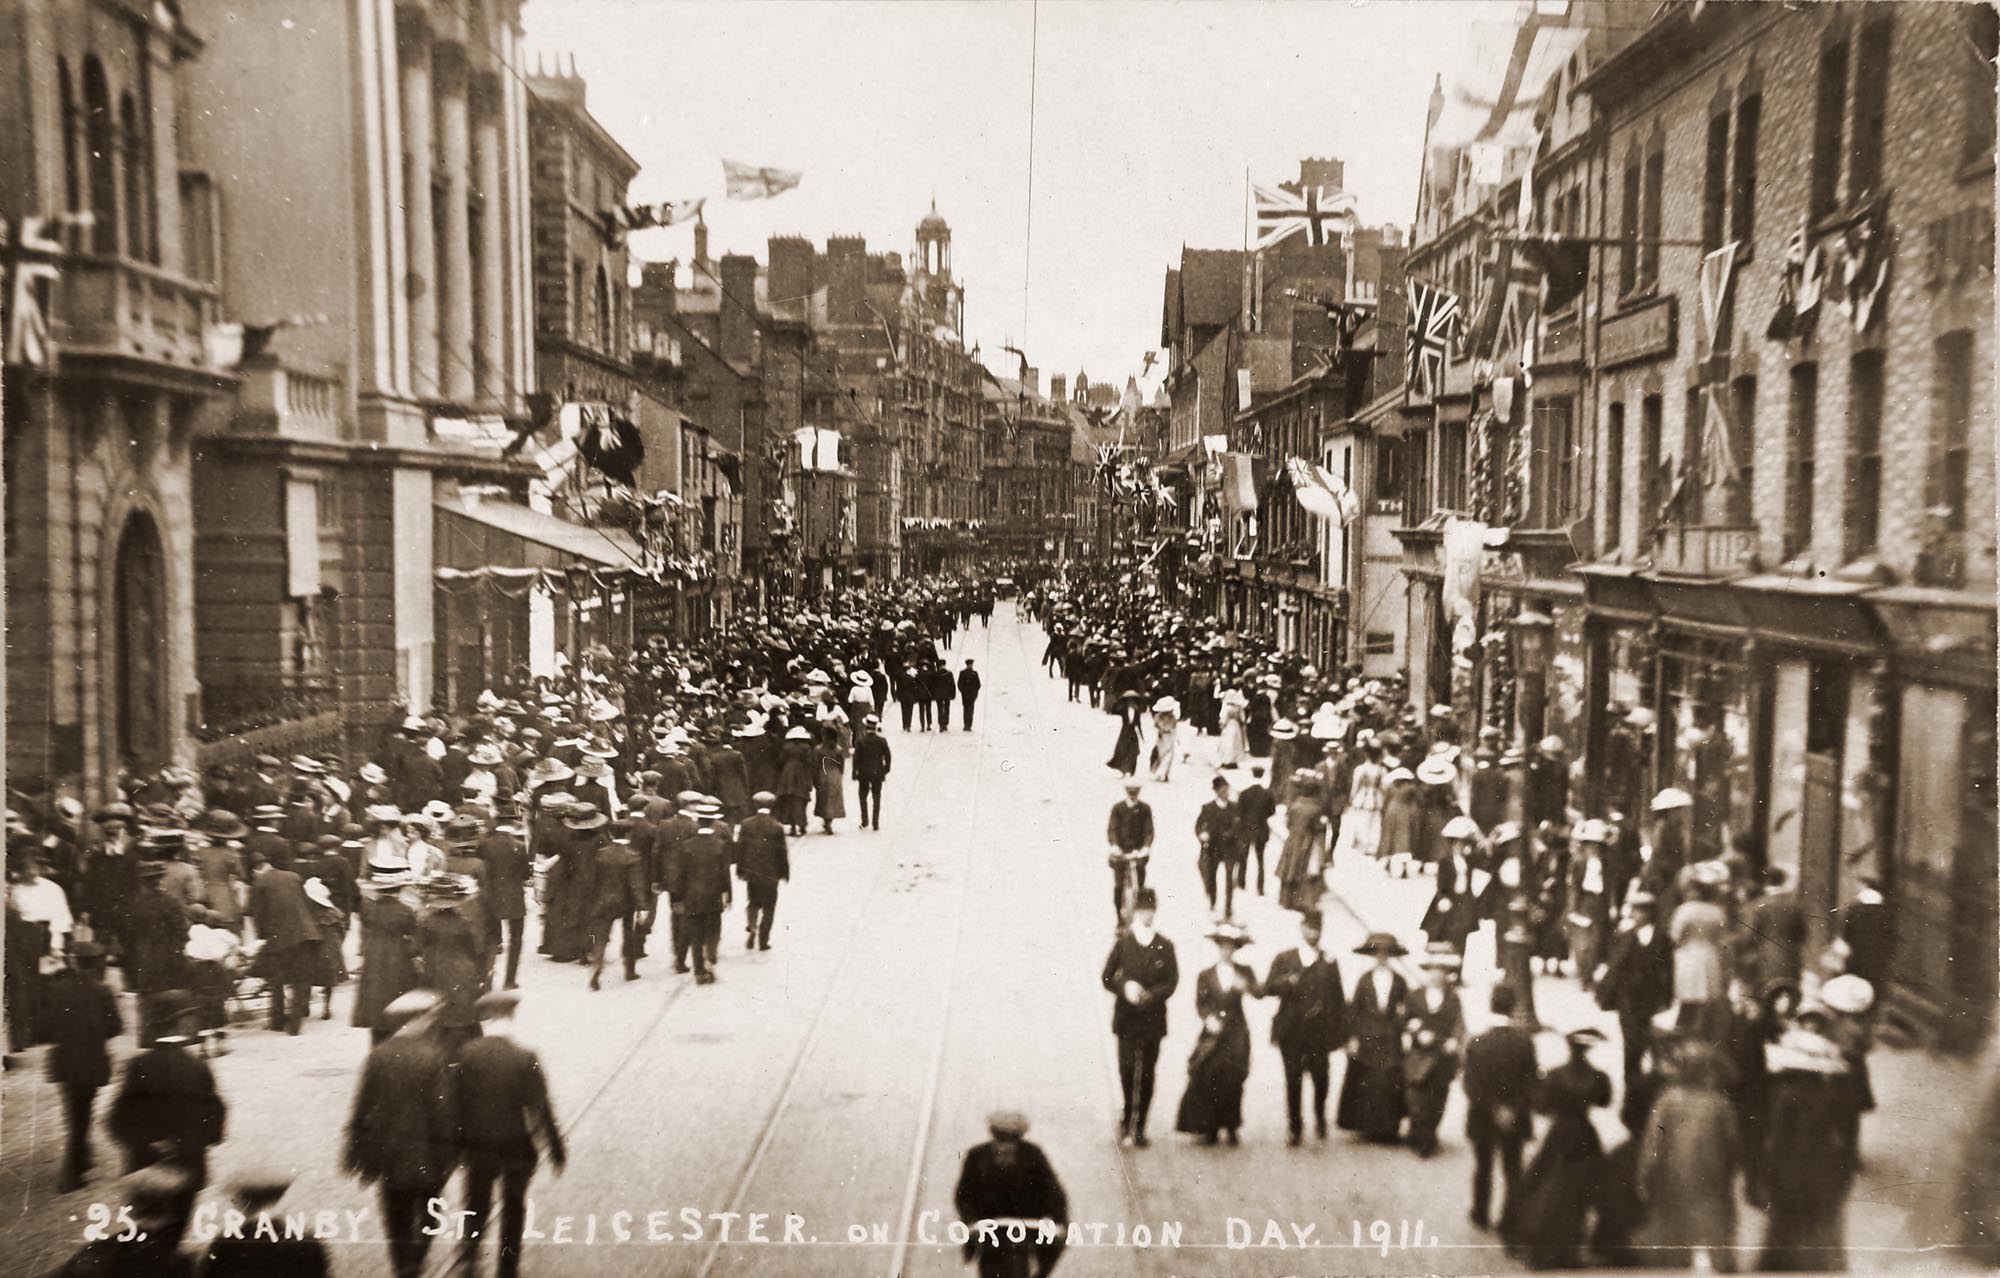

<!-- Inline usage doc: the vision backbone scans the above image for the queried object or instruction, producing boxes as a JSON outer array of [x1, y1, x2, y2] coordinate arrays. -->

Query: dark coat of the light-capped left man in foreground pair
[[346, 1034, 458, 1190]]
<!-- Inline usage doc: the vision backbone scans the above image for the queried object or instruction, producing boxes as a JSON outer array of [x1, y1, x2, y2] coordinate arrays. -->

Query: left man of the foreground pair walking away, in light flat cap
[[344, 990, 458, 1278]]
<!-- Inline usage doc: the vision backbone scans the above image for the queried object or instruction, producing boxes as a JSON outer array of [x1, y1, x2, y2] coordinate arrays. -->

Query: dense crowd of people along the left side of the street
[[6, 576, 994, 1274]]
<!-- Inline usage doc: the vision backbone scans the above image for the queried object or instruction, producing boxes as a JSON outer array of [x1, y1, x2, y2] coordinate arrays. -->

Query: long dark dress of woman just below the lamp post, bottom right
[[1500, 1058, 1612, 1268]]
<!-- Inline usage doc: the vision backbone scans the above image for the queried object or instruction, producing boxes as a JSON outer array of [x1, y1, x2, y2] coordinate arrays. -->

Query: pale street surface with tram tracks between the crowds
[[0, 604, 1970, 1278]]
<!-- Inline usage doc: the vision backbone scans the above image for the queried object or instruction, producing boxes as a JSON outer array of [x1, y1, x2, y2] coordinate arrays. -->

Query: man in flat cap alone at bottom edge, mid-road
[[952, 1110, 1070, 1278]]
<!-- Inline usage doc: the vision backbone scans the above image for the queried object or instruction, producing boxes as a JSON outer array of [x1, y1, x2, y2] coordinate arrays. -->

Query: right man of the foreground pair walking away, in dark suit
[[456, 992, 568, 1278]]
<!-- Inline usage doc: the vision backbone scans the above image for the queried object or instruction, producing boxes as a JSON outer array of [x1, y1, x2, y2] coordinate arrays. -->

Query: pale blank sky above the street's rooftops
[[522, 0, 1516, 392]]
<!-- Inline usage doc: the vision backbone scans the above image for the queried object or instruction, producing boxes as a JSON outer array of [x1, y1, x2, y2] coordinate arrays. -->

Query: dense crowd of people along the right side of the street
[[1026, 576, 1920, 1270]]
